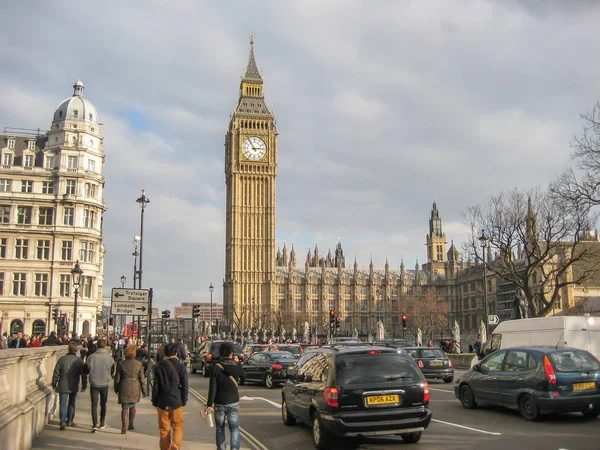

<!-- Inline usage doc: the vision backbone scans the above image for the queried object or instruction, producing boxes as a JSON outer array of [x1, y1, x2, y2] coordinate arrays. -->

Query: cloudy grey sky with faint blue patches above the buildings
[[0, 0, 600, 308]]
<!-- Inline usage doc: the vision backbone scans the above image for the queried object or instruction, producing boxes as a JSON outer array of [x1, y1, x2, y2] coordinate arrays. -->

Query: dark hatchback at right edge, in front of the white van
[[454, 346, 600, 421]]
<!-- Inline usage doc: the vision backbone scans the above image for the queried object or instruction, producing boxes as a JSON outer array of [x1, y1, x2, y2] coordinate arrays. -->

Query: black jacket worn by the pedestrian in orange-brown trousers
[[152, 358, 188, 409]]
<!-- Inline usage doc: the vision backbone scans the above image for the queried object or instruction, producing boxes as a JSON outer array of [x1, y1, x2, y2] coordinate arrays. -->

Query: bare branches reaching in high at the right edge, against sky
[[550, 102, 600, 210]]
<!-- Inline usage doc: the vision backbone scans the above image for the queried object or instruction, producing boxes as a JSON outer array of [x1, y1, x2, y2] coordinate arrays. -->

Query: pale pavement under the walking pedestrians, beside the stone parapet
[[32, 389, 223, 450]]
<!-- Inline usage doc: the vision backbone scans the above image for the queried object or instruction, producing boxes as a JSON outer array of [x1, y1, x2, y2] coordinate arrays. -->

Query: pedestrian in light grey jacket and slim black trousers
[[85, 339, 114, 433]]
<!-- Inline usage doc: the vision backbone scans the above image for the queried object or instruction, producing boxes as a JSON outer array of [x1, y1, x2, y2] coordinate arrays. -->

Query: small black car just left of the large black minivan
[[242, 352, 298, 389]]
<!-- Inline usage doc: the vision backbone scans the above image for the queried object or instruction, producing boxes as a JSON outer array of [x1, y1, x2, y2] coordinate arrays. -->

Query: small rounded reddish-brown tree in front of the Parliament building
[[403, 291, 450, 337]]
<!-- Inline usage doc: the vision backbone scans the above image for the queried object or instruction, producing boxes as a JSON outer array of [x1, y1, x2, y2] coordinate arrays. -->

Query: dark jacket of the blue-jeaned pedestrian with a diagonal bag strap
[[206, 358, 246, 407]]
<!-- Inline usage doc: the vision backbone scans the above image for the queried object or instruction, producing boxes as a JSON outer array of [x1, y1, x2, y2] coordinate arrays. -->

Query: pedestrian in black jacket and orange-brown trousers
[[152, 344, 188, 450]]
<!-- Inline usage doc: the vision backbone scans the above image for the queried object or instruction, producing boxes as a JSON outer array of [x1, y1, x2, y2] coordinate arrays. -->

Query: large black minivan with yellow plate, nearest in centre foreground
[[281, 345, 431, 449]]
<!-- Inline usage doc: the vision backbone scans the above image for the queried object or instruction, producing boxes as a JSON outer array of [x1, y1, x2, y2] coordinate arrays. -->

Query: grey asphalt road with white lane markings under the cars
[[190, 374, 600, 450]]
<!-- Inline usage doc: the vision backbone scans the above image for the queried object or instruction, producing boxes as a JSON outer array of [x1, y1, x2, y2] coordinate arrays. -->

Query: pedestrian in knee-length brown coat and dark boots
[[115, 345, 147, 434]]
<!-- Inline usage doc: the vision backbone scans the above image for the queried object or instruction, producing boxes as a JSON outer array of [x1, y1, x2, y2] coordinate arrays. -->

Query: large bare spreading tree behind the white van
[[464, 189, 599, 317]]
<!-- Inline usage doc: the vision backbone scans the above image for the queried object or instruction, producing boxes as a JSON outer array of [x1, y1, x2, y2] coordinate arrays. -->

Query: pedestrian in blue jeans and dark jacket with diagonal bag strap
[[205, 342, 245, 450]]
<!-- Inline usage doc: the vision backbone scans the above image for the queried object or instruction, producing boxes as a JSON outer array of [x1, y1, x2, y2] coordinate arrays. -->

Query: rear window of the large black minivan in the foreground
[[335, 350, 421, 384]]
